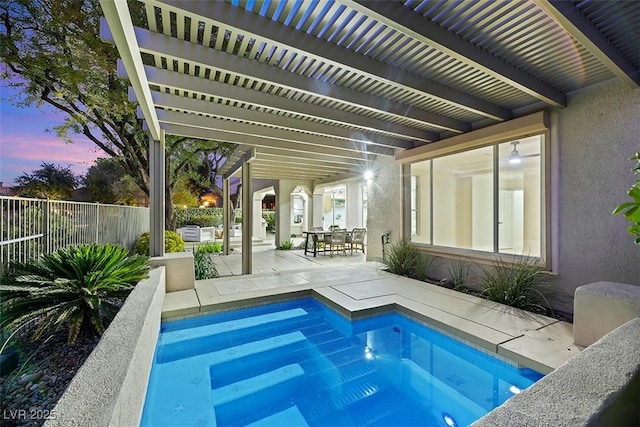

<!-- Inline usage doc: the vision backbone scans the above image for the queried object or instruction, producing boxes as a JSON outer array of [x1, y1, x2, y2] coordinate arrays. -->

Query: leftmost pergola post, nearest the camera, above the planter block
[[149, 130, 165, 257]]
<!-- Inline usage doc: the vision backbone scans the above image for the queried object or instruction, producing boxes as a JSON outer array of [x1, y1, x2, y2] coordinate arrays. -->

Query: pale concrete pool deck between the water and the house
[[162, 250, 582, 374]]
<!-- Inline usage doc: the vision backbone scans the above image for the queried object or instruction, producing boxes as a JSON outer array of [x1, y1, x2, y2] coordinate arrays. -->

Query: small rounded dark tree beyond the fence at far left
[[13, 162, 80, 200]]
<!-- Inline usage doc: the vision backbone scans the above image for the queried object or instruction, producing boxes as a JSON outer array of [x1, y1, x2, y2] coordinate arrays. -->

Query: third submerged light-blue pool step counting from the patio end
[[212, 364, 304, 425]]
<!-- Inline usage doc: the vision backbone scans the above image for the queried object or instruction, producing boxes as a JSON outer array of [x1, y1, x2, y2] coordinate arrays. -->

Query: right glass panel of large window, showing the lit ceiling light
[[498, 139, 542, 257]]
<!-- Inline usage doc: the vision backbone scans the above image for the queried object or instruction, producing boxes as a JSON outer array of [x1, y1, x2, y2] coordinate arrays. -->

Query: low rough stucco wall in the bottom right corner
[[472, 317, 640, 427]]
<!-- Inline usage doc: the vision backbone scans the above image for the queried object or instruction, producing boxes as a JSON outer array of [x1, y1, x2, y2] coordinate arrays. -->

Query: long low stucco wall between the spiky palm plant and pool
[[45, 267, 166, 427]]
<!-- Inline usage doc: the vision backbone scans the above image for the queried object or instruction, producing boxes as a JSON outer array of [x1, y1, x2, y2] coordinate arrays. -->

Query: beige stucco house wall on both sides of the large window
[[367, 81, 640, 313]]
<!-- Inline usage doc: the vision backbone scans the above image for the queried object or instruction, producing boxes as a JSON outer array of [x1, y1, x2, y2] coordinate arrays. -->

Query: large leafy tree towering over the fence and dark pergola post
[[0, 0, 235, 229]]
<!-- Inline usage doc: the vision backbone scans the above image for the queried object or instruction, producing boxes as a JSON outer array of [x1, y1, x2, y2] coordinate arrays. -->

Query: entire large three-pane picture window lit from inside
[[408, 135, 544, 257]]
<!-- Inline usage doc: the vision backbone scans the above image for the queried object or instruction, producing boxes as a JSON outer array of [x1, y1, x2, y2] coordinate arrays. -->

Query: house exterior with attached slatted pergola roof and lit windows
[[101, 0, 640, 312]]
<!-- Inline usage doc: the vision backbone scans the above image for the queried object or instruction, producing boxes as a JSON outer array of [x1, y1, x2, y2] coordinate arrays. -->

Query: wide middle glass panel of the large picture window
[[430, 147, 494, 252]]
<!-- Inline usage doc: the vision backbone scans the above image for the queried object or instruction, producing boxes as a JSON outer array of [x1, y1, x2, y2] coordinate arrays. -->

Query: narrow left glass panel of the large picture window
[[410, 160, 431, 244]]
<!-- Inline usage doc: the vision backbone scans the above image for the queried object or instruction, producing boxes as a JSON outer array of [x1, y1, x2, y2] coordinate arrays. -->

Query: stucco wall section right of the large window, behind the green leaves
[[552, 82, 640, 311]]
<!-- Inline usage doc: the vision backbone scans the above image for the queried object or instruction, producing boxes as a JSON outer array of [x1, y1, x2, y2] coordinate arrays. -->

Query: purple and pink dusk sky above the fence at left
[[0, 81, 105, 186]]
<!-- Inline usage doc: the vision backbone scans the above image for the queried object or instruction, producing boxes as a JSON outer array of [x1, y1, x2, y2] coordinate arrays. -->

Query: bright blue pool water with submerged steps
[[142, 299, 542, 427]]
